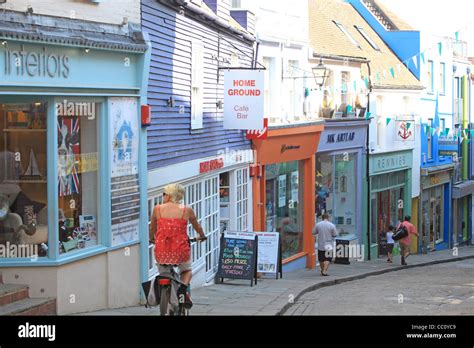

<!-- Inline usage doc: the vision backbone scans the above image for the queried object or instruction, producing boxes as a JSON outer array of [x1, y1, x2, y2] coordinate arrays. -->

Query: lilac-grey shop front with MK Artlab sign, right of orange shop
[[316, 119, 368, 247]]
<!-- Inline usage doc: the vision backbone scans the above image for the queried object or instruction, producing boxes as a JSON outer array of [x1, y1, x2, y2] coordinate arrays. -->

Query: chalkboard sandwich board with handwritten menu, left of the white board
[[216, 231, 258, 286]]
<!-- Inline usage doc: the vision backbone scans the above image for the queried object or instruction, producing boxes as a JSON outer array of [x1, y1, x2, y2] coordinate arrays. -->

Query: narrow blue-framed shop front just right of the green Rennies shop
[[419, 165, 453, 251]]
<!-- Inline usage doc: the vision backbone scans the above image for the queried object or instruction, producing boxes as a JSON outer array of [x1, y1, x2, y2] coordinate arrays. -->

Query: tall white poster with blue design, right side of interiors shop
[[108, 98, 140, 246]]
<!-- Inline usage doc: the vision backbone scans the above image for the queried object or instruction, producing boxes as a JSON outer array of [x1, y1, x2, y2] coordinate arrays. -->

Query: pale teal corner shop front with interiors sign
[[0, 16, 150, 314]]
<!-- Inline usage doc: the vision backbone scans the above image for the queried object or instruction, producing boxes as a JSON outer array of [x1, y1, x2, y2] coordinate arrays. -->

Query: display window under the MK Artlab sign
[[316, 153, 358, 236]]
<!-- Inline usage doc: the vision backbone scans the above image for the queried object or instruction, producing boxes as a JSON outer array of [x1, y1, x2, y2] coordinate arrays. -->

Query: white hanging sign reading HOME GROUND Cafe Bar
[[224, 69, 264, 130]]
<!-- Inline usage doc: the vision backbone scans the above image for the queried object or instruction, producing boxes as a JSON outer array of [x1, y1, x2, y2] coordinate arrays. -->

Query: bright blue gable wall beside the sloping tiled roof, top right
[[346, 0, 420, 80]]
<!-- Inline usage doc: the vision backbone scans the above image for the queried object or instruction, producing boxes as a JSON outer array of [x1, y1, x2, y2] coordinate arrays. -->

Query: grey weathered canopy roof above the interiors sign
[[0, 11, 147, 53]]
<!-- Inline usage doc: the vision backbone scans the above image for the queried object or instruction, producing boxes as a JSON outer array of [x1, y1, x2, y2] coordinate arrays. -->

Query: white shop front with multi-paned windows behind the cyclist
[[146, 149, 254, 288]]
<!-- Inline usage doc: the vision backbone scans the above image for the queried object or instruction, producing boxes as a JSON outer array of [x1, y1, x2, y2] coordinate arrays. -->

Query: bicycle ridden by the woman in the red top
[[158, 238, 207, 316]]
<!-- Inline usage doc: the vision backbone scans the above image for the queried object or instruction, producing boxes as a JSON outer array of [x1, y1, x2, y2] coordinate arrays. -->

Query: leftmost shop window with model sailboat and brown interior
[[0, 102, 48, 258]]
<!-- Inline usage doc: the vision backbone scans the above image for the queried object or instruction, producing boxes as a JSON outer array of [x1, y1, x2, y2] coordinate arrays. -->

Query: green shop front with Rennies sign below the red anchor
[[369, 150, 413, 258]]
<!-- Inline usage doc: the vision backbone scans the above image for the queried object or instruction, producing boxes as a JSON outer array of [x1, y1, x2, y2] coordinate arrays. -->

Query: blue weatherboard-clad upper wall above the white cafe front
[[141, 0, 253, 170]]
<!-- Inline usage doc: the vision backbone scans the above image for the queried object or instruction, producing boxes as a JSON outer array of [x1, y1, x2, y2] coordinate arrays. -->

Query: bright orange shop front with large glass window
[[252, 121, 324, 271]]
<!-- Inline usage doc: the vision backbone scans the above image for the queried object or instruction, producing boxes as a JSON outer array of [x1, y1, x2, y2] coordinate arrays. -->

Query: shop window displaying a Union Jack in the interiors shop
[[57, 103, 99, 254]]
